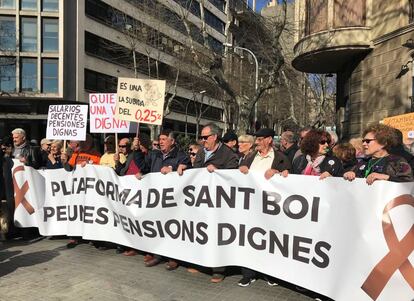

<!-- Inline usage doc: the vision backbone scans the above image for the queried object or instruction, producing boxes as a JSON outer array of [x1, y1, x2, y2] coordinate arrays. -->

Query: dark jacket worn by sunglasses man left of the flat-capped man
[[194, 143, 239, 169]]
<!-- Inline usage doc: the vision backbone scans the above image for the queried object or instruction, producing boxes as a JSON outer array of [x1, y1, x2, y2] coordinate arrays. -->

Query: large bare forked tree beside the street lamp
[[175, 0, 292, 133]]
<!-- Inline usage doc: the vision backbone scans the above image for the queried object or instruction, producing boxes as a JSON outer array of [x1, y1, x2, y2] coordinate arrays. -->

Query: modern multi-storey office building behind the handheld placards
[[0, 0, 227, 139]]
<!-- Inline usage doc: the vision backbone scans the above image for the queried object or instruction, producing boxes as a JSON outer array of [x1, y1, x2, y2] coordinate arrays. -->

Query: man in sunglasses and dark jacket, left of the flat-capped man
[[193, 123, 239, 283]]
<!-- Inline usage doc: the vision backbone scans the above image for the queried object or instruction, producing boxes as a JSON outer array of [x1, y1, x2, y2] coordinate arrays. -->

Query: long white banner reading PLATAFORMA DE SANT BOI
[[13, 165, 414, 301]]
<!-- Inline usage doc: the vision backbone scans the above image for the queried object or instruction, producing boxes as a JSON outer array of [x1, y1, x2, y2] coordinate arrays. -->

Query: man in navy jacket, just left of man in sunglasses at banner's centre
[[137, 129, 191, 271]]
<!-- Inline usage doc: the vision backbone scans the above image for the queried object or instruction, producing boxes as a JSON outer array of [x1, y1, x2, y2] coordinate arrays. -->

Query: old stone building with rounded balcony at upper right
[[292, 0, 414, 138]]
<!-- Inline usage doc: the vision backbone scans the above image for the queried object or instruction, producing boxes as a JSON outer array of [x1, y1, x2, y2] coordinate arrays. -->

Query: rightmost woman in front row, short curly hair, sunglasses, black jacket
[[344, 124, 413, 185]]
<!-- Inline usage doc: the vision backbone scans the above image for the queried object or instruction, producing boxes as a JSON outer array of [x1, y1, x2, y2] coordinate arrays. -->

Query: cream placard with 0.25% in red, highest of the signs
[[116, 77, 165, 125]]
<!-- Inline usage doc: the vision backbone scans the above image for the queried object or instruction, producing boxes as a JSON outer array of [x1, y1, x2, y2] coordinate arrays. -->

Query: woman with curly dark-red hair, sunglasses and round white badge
[[292, 129, 344, 180]]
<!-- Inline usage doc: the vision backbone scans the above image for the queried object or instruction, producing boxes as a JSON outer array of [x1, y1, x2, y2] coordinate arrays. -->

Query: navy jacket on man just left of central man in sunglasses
[[144, 147, 191, 172]]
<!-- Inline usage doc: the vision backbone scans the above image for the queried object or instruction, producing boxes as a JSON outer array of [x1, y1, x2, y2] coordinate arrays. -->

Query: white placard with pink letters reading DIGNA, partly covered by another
[[89, 93, 129, 133]]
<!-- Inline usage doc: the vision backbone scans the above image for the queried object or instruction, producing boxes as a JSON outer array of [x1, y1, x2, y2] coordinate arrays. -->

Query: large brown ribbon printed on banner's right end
[[361, 194, 414, 300]]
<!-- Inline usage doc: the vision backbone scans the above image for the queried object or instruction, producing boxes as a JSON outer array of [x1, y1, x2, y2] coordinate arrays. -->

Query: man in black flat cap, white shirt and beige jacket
[[239, 128, 291, 287]]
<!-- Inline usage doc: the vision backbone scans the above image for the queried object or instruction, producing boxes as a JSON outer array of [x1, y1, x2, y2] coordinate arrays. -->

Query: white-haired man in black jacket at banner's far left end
[[12, 128, 42, 168]]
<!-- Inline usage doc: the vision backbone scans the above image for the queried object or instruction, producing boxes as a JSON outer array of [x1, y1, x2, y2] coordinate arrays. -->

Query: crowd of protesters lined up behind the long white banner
[[0, 124, 414, 286]]
